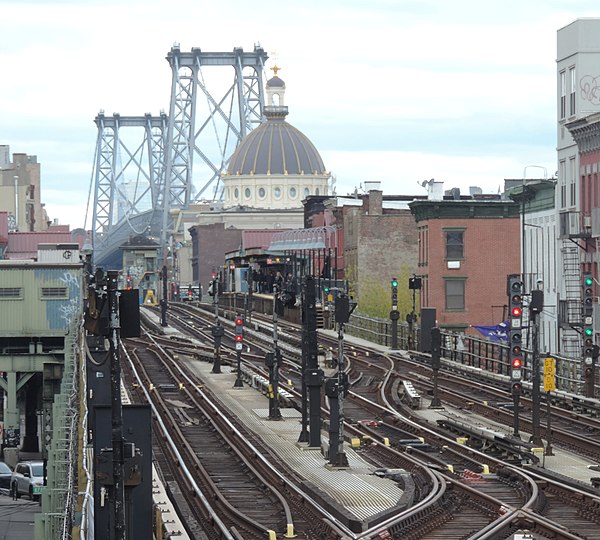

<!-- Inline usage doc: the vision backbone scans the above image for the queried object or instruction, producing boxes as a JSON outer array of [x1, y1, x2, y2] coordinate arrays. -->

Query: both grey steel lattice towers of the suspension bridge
[[92, 45, 268, 262]]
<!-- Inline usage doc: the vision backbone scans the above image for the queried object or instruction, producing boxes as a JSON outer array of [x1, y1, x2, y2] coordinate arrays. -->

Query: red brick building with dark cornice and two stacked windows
[[409, 182, 521, 332]]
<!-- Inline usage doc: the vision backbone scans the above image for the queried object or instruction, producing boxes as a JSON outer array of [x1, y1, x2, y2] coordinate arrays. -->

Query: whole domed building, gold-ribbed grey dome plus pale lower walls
[[176, 67, 331, 290]]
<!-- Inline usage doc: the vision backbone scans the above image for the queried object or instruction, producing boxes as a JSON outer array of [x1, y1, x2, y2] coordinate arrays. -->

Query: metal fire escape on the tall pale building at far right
[[559, 211, 592, 358]]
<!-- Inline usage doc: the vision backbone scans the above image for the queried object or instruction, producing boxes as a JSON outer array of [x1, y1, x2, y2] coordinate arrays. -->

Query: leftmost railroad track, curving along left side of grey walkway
[[120, 334, 346, 540]]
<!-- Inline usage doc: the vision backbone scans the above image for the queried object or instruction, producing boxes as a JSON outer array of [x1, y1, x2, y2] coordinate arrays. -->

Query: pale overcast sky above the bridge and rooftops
[[0, 0, 600, 228]]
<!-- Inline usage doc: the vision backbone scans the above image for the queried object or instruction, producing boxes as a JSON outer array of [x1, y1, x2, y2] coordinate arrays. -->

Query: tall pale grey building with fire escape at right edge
[[555, 18, 600, 357]]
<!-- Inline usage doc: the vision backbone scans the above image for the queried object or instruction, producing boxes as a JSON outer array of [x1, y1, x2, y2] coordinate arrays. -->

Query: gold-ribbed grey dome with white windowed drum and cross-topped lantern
[[221, 66, 331, 209]]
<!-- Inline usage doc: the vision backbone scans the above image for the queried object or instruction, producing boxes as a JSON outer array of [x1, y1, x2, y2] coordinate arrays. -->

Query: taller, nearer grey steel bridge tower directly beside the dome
[[166, 45, 268, 208]]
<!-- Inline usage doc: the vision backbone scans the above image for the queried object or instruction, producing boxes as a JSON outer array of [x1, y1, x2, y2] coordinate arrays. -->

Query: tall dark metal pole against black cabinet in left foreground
[[107, 270, 126, 540]]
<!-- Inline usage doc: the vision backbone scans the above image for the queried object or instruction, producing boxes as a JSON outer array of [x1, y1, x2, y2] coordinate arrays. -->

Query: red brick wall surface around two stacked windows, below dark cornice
[[420, 218, 521, 326]]
